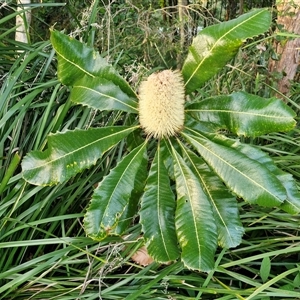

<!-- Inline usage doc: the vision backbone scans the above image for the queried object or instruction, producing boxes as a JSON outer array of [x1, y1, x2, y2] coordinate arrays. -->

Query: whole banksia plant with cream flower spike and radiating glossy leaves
[[22, 9, 300, 272]]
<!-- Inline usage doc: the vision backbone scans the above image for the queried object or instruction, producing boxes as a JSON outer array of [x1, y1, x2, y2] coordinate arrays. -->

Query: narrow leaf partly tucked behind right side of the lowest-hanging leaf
[[182, 146, 244, 248]]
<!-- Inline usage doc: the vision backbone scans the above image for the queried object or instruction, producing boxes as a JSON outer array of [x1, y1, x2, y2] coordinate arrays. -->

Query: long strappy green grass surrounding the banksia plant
[[0, 1, 300, 300]]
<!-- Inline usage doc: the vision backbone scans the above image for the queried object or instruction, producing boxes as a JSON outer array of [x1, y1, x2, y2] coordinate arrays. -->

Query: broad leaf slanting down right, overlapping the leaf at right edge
[[182, 132, 286, 206]]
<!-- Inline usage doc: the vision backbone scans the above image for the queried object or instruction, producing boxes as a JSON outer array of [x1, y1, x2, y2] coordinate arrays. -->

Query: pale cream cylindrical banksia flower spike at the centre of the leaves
[[139, 70, 184, 139]]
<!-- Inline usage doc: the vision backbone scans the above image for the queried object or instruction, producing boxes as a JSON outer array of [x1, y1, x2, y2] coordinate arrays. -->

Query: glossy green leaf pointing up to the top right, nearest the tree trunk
[[182, 9, 271, 94]]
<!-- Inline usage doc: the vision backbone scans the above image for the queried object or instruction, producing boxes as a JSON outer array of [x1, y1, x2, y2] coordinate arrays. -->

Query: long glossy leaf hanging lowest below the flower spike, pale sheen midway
[[172, 147, 217, 272]]
